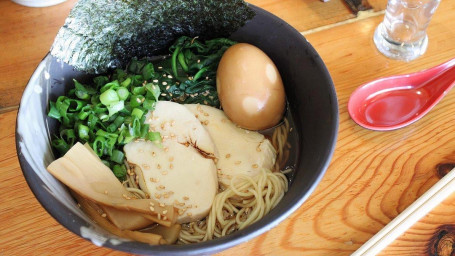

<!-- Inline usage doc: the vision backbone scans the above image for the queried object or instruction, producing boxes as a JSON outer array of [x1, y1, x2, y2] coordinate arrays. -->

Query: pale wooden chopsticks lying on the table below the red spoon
[[351, 168, 455, 256]]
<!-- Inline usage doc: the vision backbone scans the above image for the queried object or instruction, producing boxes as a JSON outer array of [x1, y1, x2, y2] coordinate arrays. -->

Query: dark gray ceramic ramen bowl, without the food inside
[[16, 6, 338, 255]]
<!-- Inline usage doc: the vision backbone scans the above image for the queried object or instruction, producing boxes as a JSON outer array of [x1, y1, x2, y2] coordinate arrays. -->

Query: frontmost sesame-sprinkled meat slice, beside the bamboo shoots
[[123, 139, 218, 223]]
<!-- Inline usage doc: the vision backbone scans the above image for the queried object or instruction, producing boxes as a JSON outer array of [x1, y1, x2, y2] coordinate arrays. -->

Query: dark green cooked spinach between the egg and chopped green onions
[[154, 36, 236, 107]]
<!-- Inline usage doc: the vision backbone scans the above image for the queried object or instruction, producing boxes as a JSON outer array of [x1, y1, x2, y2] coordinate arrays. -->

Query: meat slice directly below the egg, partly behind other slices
[[185, 104, 276, 186]]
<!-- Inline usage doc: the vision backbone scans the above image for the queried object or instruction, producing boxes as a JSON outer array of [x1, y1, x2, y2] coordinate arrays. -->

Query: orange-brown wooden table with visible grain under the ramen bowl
[[0, 0, 455, 255]]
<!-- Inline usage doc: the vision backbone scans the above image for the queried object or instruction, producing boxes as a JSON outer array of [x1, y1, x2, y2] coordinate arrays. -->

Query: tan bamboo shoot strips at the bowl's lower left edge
[[47, 143, 175, 230]]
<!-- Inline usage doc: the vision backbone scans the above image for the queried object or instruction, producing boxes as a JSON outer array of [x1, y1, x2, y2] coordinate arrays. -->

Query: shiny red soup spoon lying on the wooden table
[[348, 59, 455, 131]]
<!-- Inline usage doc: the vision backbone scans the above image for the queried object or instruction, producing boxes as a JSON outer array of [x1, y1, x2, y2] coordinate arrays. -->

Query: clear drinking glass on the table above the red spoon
[[373, 0, 440, 61]]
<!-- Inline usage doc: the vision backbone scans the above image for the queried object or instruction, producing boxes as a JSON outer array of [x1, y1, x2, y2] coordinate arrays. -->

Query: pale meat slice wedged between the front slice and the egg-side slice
[[145, 101, 218, 158]]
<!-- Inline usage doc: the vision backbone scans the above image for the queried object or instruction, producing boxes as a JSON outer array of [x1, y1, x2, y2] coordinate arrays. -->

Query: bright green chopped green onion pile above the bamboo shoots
[[48, 63, 161, 179]]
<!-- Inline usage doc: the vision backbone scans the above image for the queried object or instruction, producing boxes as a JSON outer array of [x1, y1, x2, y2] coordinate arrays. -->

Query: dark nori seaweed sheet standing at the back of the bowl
[[51, 0, 254, 74]]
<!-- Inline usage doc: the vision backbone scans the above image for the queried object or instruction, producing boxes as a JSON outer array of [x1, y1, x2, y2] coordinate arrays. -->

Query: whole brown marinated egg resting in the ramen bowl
[[216, 43, 285, 130]]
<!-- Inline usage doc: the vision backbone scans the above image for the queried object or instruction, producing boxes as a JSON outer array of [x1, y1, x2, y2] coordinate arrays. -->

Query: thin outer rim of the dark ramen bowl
[[15, 4, 339, 255]]
